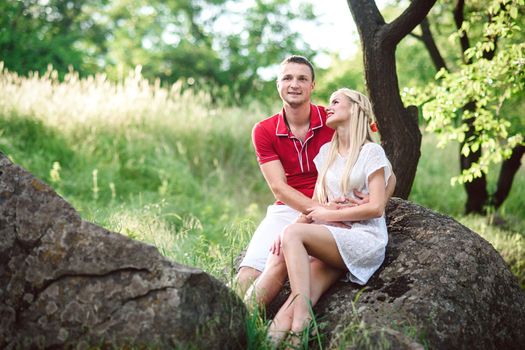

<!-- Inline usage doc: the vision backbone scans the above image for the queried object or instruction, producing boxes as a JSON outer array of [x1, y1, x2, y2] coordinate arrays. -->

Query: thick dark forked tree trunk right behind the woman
[[348, 0, 435, 199]]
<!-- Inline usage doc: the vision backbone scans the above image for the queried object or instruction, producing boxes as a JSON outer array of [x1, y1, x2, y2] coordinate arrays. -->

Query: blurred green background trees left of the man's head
[[0, 0, 315, 103]]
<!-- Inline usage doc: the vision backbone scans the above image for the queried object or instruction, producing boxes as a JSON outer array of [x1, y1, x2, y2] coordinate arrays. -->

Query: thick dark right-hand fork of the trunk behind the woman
[[382, 0, 436, 47]]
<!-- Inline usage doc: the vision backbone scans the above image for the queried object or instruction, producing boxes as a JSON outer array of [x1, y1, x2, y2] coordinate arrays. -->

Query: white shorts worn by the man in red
[[239, 204, 299, 271]]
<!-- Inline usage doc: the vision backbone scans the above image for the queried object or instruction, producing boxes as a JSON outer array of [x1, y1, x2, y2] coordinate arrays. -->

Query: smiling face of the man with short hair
[[277, 62, 315, 107]]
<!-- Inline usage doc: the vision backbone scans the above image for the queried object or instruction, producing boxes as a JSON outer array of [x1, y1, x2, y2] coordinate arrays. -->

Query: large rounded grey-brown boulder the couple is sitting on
[[260, 198, 525, 349]]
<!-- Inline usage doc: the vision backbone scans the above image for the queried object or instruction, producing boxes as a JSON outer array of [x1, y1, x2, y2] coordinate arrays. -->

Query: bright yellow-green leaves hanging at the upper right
[[412, 0, 525, 186]]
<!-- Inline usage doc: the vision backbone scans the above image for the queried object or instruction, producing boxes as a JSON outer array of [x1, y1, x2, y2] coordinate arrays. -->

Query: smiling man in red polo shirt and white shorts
[[237, 56, 395, 298]]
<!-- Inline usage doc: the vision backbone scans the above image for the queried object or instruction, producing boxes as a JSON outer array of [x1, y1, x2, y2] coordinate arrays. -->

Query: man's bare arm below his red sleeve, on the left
[[260, 160, 319, 214]]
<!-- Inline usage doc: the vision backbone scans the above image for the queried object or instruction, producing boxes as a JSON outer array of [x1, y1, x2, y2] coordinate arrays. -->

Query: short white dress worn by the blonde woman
[[314, 143, 392, 284]]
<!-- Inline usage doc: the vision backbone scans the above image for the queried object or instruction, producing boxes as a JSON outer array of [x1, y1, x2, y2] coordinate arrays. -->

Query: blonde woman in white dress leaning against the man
[[248, 89, 392, 343]]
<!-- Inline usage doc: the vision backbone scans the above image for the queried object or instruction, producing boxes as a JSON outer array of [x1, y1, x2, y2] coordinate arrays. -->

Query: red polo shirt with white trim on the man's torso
[[252, 104, 334, 204]]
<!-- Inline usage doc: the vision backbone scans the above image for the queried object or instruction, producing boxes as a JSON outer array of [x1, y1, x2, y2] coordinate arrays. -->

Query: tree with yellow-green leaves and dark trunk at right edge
[[405, 0, 525, 212]]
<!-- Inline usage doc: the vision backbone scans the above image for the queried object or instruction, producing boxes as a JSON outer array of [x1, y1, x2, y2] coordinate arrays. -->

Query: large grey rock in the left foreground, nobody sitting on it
[[0, 153, 246, 349]]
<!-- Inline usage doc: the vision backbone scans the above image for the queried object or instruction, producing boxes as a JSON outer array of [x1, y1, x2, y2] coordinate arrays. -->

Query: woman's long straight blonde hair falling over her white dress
[[315, 88, 375, 203]]
